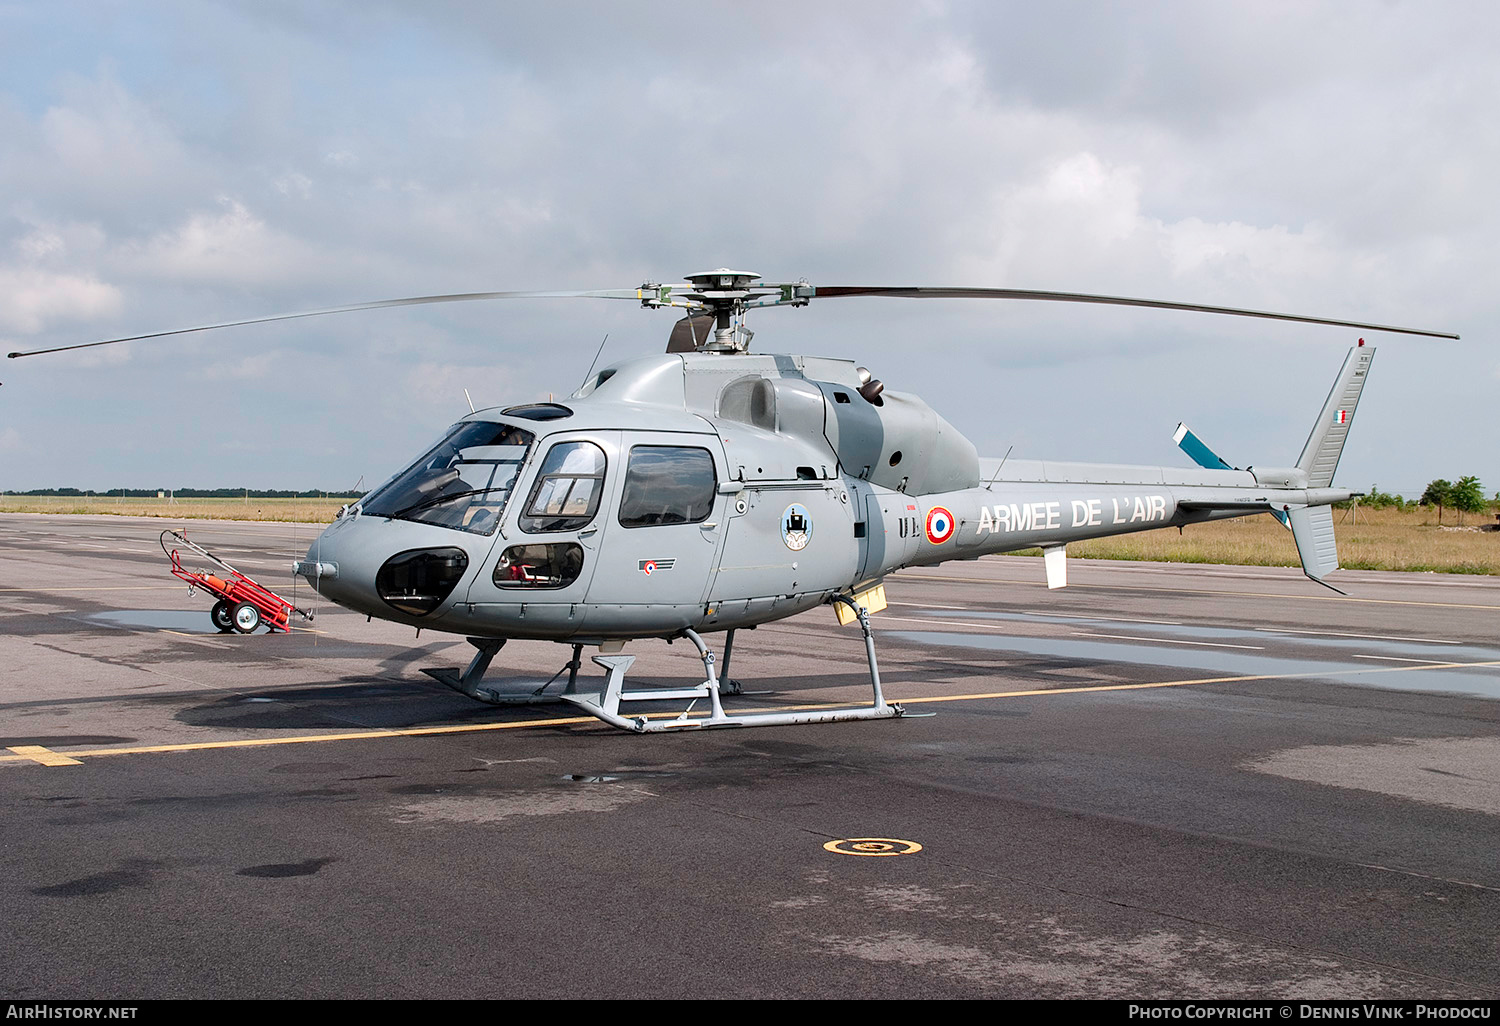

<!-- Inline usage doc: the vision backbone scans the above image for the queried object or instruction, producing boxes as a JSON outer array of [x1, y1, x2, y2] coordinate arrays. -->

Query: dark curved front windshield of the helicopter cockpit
[[360, 420, 536, 534]]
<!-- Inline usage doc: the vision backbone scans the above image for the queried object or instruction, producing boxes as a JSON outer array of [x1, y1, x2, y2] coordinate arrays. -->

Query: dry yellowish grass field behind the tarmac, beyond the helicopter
[[0, 495, 1500, 575]]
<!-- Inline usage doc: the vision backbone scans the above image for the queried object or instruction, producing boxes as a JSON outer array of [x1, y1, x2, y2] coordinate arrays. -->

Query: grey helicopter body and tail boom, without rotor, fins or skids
[[299, 353, 1349, 644]]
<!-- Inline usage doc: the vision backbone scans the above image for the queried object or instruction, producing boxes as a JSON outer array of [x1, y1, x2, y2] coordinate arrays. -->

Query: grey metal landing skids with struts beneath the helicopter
[[423, 596, 906, 734]]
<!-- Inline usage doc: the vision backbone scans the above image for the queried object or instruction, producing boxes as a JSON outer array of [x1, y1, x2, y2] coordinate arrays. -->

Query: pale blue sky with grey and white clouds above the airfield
[[0, 0, 1500, 494]]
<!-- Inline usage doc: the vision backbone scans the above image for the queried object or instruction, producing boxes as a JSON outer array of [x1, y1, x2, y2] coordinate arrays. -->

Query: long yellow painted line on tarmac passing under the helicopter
[[0, 660, 1500, 765]]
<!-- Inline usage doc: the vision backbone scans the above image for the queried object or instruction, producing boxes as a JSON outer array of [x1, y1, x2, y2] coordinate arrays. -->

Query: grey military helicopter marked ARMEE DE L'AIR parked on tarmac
[[9, 267, 1458, 732]]
